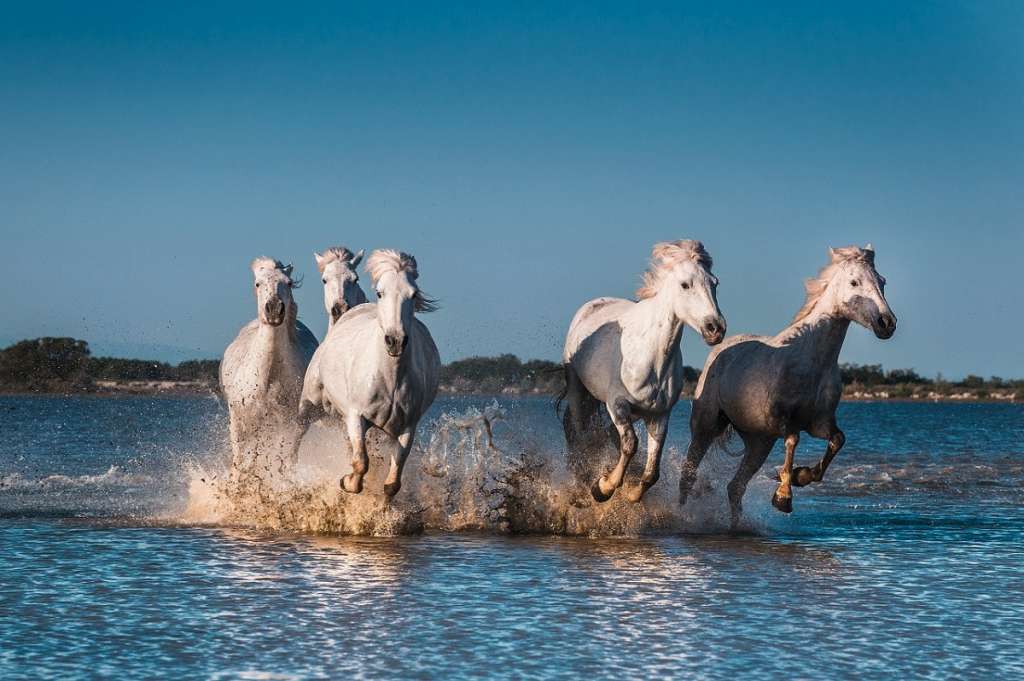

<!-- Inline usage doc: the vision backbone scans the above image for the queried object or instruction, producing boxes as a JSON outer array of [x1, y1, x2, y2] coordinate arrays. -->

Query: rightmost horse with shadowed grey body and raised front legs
[[679, 244, 896, 529]]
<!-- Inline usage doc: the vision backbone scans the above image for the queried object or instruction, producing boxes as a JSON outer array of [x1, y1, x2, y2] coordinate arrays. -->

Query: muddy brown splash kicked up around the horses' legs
[[178, 401, 770, 537]]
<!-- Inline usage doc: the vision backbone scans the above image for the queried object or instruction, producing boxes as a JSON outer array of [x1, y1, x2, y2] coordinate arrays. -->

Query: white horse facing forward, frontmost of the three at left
[[302, 250, 440, 498]]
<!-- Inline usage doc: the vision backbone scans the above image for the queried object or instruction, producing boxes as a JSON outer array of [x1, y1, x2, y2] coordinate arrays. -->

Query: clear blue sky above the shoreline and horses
[[0, 2, 1024, 376]]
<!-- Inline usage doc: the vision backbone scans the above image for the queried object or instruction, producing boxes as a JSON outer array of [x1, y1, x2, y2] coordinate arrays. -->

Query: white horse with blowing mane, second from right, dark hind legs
[[561, 241, 725, 502]]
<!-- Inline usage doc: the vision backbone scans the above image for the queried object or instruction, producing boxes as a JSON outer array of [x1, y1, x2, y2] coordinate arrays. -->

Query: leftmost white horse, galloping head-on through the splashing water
[[220, 258, 316, 471]]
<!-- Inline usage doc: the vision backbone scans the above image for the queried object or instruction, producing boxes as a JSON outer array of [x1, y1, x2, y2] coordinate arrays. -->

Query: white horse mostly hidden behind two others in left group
[[299, 246, 367, 434]]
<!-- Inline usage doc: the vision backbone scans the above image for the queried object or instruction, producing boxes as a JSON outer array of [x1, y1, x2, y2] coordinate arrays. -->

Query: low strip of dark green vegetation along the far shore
[[0, 338, 1024, 401]]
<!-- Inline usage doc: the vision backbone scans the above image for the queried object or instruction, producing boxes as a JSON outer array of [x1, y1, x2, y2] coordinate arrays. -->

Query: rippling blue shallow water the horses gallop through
[[0, 397, 1024, 679]]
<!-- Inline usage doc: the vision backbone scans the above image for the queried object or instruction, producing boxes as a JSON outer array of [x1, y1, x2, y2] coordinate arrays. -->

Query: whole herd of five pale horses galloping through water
[[220, 240, 896, 527]]
